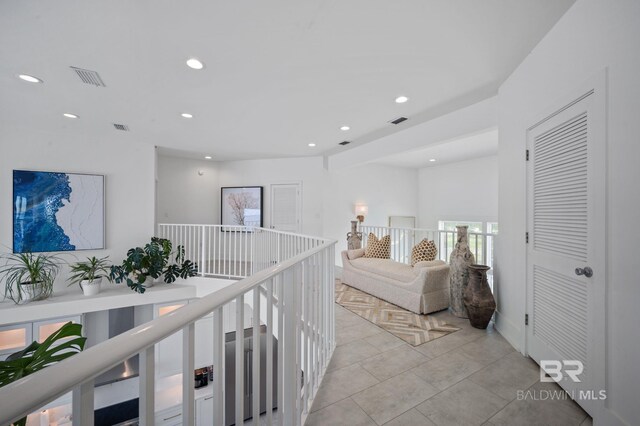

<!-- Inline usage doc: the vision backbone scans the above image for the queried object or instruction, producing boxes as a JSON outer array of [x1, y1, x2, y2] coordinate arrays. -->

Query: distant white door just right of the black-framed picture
[[271, 183, 302, 232]]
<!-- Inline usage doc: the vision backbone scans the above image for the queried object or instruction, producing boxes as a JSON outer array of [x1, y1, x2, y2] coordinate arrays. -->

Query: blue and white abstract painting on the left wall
[[13, 170, 105, 253]]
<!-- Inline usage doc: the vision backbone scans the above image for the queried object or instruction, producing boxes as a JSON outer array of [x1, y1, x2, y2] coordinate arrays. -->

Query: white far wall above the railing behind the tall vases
[[418, 155, 498, 229]]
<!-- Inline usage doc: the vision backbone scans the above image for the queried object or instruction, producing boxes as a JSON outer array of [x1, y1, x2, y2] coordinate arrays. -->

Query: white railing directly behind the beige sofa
[[359, 225, 497, 278]]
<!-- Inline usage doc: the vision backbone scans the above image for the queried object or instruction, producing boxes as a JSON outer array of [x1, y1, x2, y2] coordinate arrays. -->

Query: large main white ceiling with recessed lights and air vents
[[0, 0, 574, 160]]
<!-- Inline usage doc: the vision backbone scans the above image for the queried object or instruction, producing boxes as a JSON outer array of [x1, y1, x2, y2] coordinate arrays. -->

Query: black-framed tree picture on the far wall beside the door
[[220, 186, 262, 227]]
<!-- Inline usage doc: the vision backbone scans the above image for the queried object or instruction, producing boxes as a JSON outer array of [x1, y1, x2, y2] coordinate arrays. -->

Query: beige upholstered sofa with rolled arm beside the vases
[[342, 249, 449, 314]]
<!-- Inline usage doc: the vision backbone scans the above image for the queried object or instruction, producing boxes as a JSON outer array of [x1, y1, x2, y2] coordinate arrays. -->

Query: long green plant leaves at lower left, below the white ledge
[[0, 322, 87, 426]]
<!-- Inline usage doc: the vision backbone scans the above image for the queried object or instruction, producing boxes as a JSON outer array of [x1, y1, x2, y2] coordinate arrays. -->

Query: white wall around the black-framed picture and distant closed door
[[218, 157, 326, 236]]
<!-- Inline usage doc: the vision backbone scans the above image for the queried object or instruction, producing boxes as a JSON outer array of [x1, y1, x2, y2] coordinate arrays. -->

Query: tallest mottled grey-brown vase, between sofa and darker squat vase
[[449, 226, 475, 318]]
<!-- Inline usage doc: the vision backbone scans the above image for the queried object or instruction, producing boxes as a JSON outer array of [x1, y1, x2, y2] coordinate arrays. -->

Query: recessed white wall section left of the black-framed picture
[[156, 155, 220, 223]]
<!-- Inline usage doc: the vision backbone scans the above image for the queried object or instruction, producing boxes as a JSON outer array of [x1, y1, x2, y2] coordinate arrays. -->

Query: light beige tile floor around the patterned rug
[[306, 305, 591, 426]]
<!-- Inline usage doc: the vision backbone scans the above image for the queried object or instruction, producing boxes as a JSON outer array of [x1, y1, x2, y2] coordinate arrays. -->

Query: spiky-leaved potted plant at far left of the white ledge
[[0, 252, 62, 305]]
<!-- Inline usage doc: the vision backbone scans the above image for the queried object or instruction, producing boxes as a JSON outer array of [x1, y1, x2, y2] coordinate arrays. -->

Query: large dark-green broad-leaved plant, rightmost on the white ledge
[[110, 237, 198, 293]]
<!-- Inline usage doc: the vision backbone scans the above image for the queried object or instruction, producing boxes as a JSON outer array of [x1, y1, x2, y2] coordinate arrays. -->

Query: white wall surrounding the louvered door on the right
[[496, 0, 640, 425]]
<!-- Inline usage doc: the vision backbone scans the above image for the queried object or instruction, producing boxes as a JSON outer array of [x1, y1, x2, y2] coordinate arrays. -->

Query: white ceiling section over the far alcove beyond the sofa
[[375, 129, 498, 168]]
